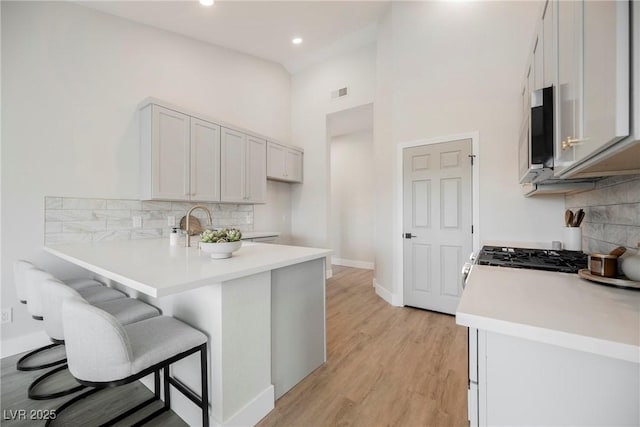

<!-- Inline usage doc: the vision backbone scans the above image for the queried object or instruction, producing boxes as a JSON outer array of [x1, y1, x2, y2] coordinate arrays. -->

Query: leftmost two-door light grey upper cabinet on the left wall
[[140, 104, 220, 202]]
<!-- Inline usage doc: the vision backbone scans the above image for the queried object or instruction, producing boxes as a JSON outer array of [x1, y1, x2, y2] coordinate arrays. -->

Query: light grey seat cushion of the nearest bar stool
[[124, 316, 207, 375]]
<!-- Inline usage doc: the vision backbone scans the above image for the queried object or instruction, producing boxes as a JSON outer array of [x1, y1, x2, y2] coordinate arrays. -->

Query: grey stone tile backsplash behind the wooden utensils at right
[[565, 175, 640, 253]]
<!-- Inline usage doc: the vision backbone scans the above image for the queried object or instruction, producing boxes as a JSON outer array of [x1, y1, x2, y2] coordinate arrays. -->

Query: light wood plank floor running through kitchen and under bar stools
[[0, 266, 468, 427]]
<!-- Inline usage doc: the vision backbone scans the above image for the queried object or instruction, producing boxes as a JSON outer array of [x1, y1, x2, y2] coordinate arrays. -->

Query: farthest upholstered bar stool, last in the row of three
[[14, 260, 124, 371]]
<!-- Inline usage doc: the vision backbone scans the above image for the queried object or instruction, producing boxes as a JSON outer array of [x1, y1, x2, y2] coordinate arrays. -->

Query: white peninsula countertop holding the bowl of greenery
[[44, 239, 331, 297]]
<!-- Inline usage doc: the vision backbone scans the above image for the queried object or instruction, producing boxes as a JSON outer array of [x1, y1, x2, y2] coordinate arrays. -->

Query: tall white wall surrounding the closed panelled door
[[374, 2, 563, 293]]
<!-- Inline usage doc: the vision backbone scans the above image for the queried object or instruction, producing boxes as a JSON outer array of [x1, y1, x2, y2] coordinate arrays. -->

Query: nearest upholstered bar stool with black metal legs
[[51, 298, 209, 426]]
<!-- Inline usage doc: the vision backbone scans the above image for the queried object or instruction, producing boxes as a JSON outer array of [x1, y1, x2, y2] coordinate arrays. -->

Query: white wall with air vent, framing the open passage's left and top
[[291, 45, 376, 251]]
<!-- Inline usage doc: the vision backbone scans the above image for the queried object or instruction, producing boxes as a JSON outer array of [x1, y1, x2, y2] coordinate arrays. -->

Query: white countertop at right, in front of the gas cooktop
[[456, 265, 640, 363]]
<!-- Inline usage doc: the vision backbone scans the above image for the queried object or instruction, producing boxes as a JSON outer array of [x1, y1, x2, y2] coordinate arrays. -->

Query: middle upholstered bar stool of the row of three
[[28, 277, 160, 400]]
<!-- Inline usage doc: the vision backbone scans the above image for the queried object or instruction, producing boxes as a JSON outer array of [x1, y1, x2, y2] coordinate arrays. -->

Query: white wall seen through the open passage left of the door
[[330, 129, 375, 266]]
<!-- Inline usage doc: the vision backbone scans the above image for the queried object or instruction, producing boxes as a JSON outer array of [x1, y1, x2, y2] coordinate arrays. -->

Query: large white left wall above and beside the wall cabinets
[[1, 2, 290, 342]]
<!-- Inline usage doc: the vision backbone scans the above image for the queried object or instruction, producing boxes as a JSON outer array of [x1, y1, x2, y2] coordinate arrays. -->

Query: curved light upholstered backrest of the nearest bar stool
[[62, 297, 133, 382]]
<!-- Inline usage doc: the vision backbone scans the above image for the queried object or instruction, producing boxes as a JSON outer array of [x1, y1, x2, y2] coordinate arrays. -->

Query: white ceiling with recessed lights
[[78, 0, 389, 72]]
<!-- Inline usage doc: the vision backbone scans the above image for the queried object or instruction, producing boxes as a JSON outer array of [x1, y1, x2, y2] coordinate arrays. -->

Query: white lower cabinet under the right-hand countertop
[[468, 329, 640, 426]]
